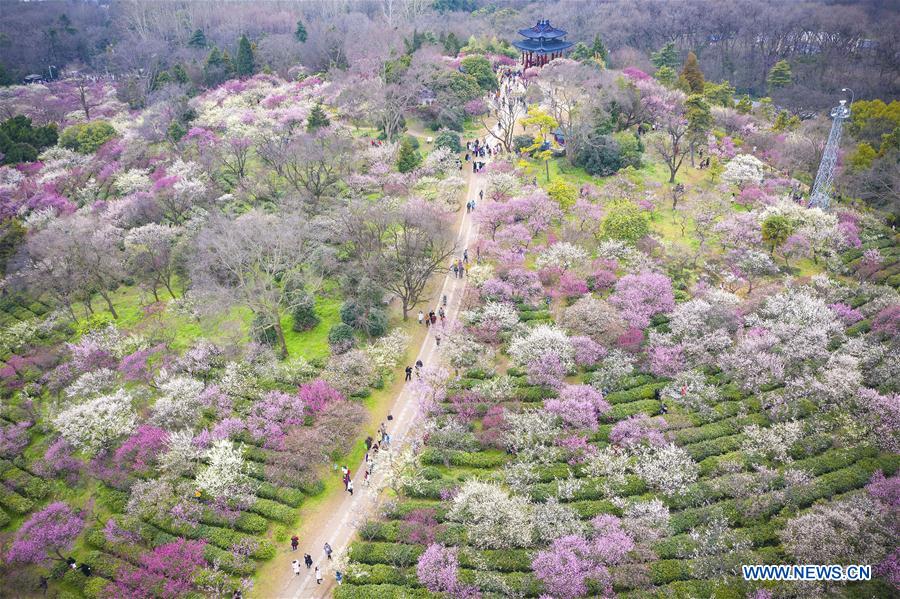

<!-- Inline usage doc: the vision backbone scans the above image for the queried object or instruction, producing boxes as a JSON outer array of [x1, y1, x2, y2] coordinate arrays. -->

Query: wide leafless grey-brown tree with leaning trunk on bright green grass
[[191, 210, 313, 356]]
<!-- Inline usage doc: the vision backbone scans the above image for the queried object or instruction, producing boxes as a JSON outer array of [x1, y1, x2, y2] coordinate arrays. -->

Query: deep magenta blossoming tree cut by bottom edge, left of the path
[[106, 539, 206, 599]]
